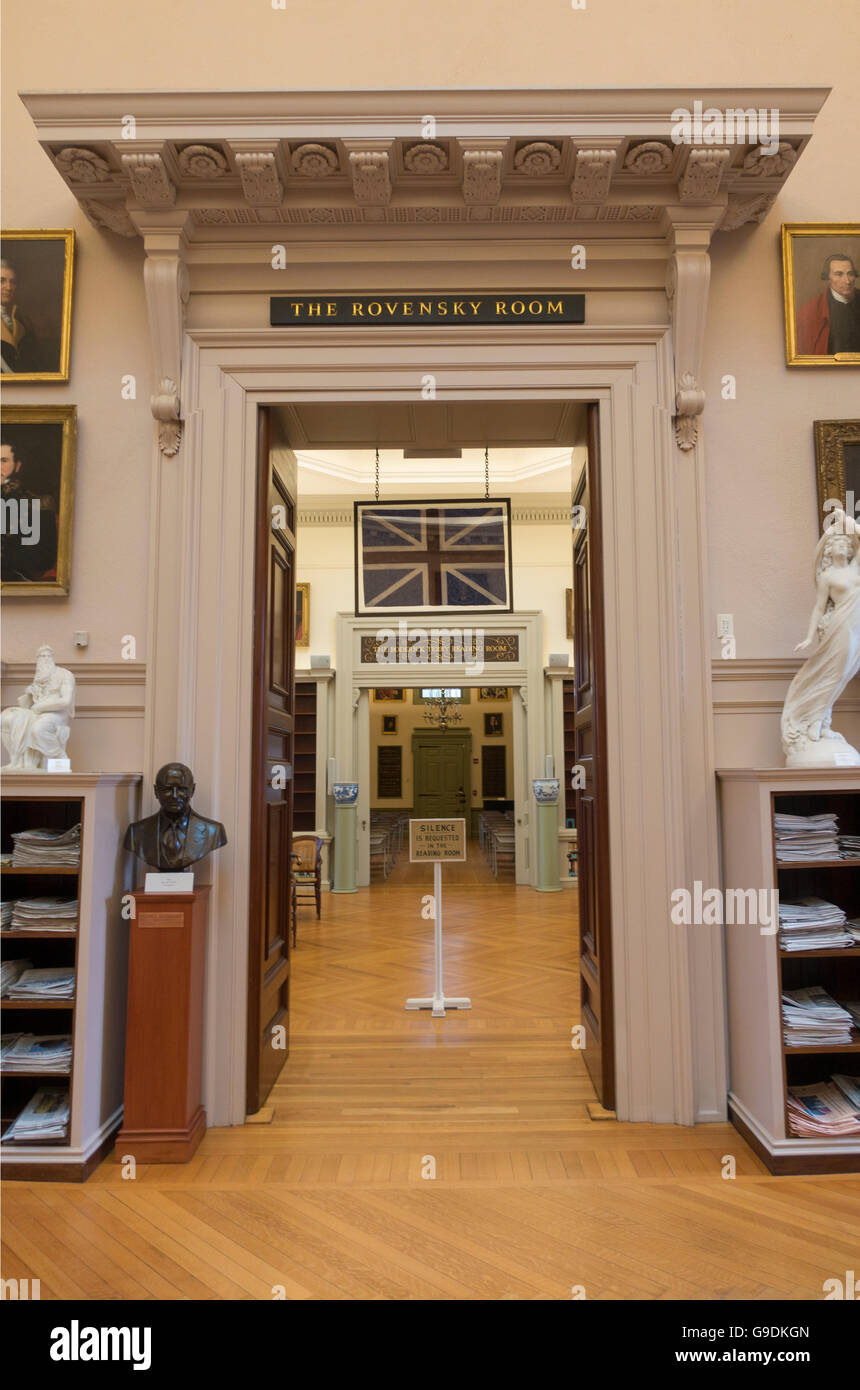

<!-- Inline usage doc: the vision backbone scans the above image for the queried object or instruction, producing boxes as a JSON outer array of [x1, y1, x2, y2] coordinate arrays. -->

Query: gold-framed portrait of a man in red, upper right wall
[[782, 222, 860, 367]]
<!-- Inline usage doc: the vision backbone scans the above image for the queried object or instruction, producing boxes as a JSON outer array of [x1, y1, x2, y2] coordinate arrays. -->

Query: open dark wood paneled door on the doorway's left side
[[246, 407, 296, 1115]]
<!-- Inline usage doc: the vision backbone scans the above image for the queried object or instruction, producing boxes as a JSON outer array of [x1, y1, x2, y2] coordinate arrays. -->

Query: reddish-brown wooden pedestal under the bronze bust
[[114, 887, 210, 1163]]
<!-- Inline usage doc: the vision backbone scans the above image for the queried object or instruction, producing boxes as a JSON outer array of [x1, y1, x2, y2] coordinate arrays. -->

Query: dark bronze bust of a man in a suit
[[125, 763, 226, 873]]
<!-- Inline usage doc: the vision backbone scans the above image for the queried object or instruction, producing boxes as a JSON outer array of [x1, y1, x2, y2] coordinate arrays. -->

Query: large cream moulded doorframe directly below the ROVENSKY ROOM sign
[[152, 324, 727, 1125]]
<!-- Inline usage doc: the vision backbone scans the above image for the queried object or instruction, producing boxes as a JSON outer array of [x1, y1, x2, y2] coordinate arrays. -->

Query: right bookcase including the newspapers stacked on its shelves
[[717, 767, 860, 1173]]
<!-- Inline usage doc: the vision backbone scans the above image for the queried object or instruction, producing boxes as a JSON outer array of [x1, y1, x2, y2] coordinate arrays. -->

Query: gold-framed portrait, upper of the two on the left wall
[[0, 231, 75, 382]]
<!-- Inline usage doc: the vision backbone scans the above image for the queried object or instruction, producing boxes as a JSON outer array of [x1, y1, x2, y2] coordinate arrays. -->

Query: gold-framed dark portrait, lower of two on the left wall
[[0, 406, 76, 598]]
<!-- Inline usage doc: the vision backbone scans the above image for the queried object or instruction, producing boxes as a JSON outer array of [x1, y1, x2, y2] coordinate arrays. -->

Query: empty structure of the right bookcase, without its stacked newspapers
[[722, 767, 860, 1173]]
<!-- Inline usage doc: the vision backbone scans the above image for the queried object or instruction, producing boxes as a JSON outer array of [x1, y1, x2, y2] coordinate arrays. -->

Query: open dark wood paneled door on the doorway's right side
[[572, 403, 615, 1111]]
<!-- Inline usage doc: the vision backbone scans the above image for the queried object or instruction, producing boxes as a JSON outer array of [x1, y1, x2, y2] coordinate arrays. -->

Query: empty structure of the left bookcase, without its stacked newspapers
[[0, 773, 140, 1182]]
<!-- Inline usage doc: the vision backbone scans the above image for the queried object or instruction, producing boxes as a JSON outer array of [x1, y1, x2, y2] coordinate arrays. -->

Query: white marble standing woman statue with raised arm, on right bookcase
[[782, 509, 860, 767]]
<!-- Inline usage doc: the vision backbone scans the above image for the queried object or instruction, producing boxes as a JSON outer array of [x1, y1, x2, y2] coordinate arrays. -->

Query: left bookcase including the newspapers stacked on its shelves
[[0, 771, 140, 1182]]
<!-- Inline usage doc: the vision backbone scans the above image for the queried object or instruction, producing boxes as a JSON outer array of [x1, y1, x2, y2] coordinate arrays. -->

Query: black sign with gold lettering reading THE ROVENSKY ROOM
[[270, 291, 585, 328]]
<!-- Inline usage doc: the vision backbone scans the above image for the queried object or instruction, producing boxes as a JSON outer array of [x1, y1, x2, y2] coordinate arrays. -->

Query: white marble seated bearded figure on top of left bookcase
[[0, 646, 75, 773]]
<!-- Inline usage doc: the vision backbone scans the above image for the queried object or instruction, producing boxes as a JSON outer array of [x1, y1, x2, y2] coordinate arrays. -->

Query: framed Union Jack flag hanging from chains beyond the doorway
[[356, 498, 513, 616]]
